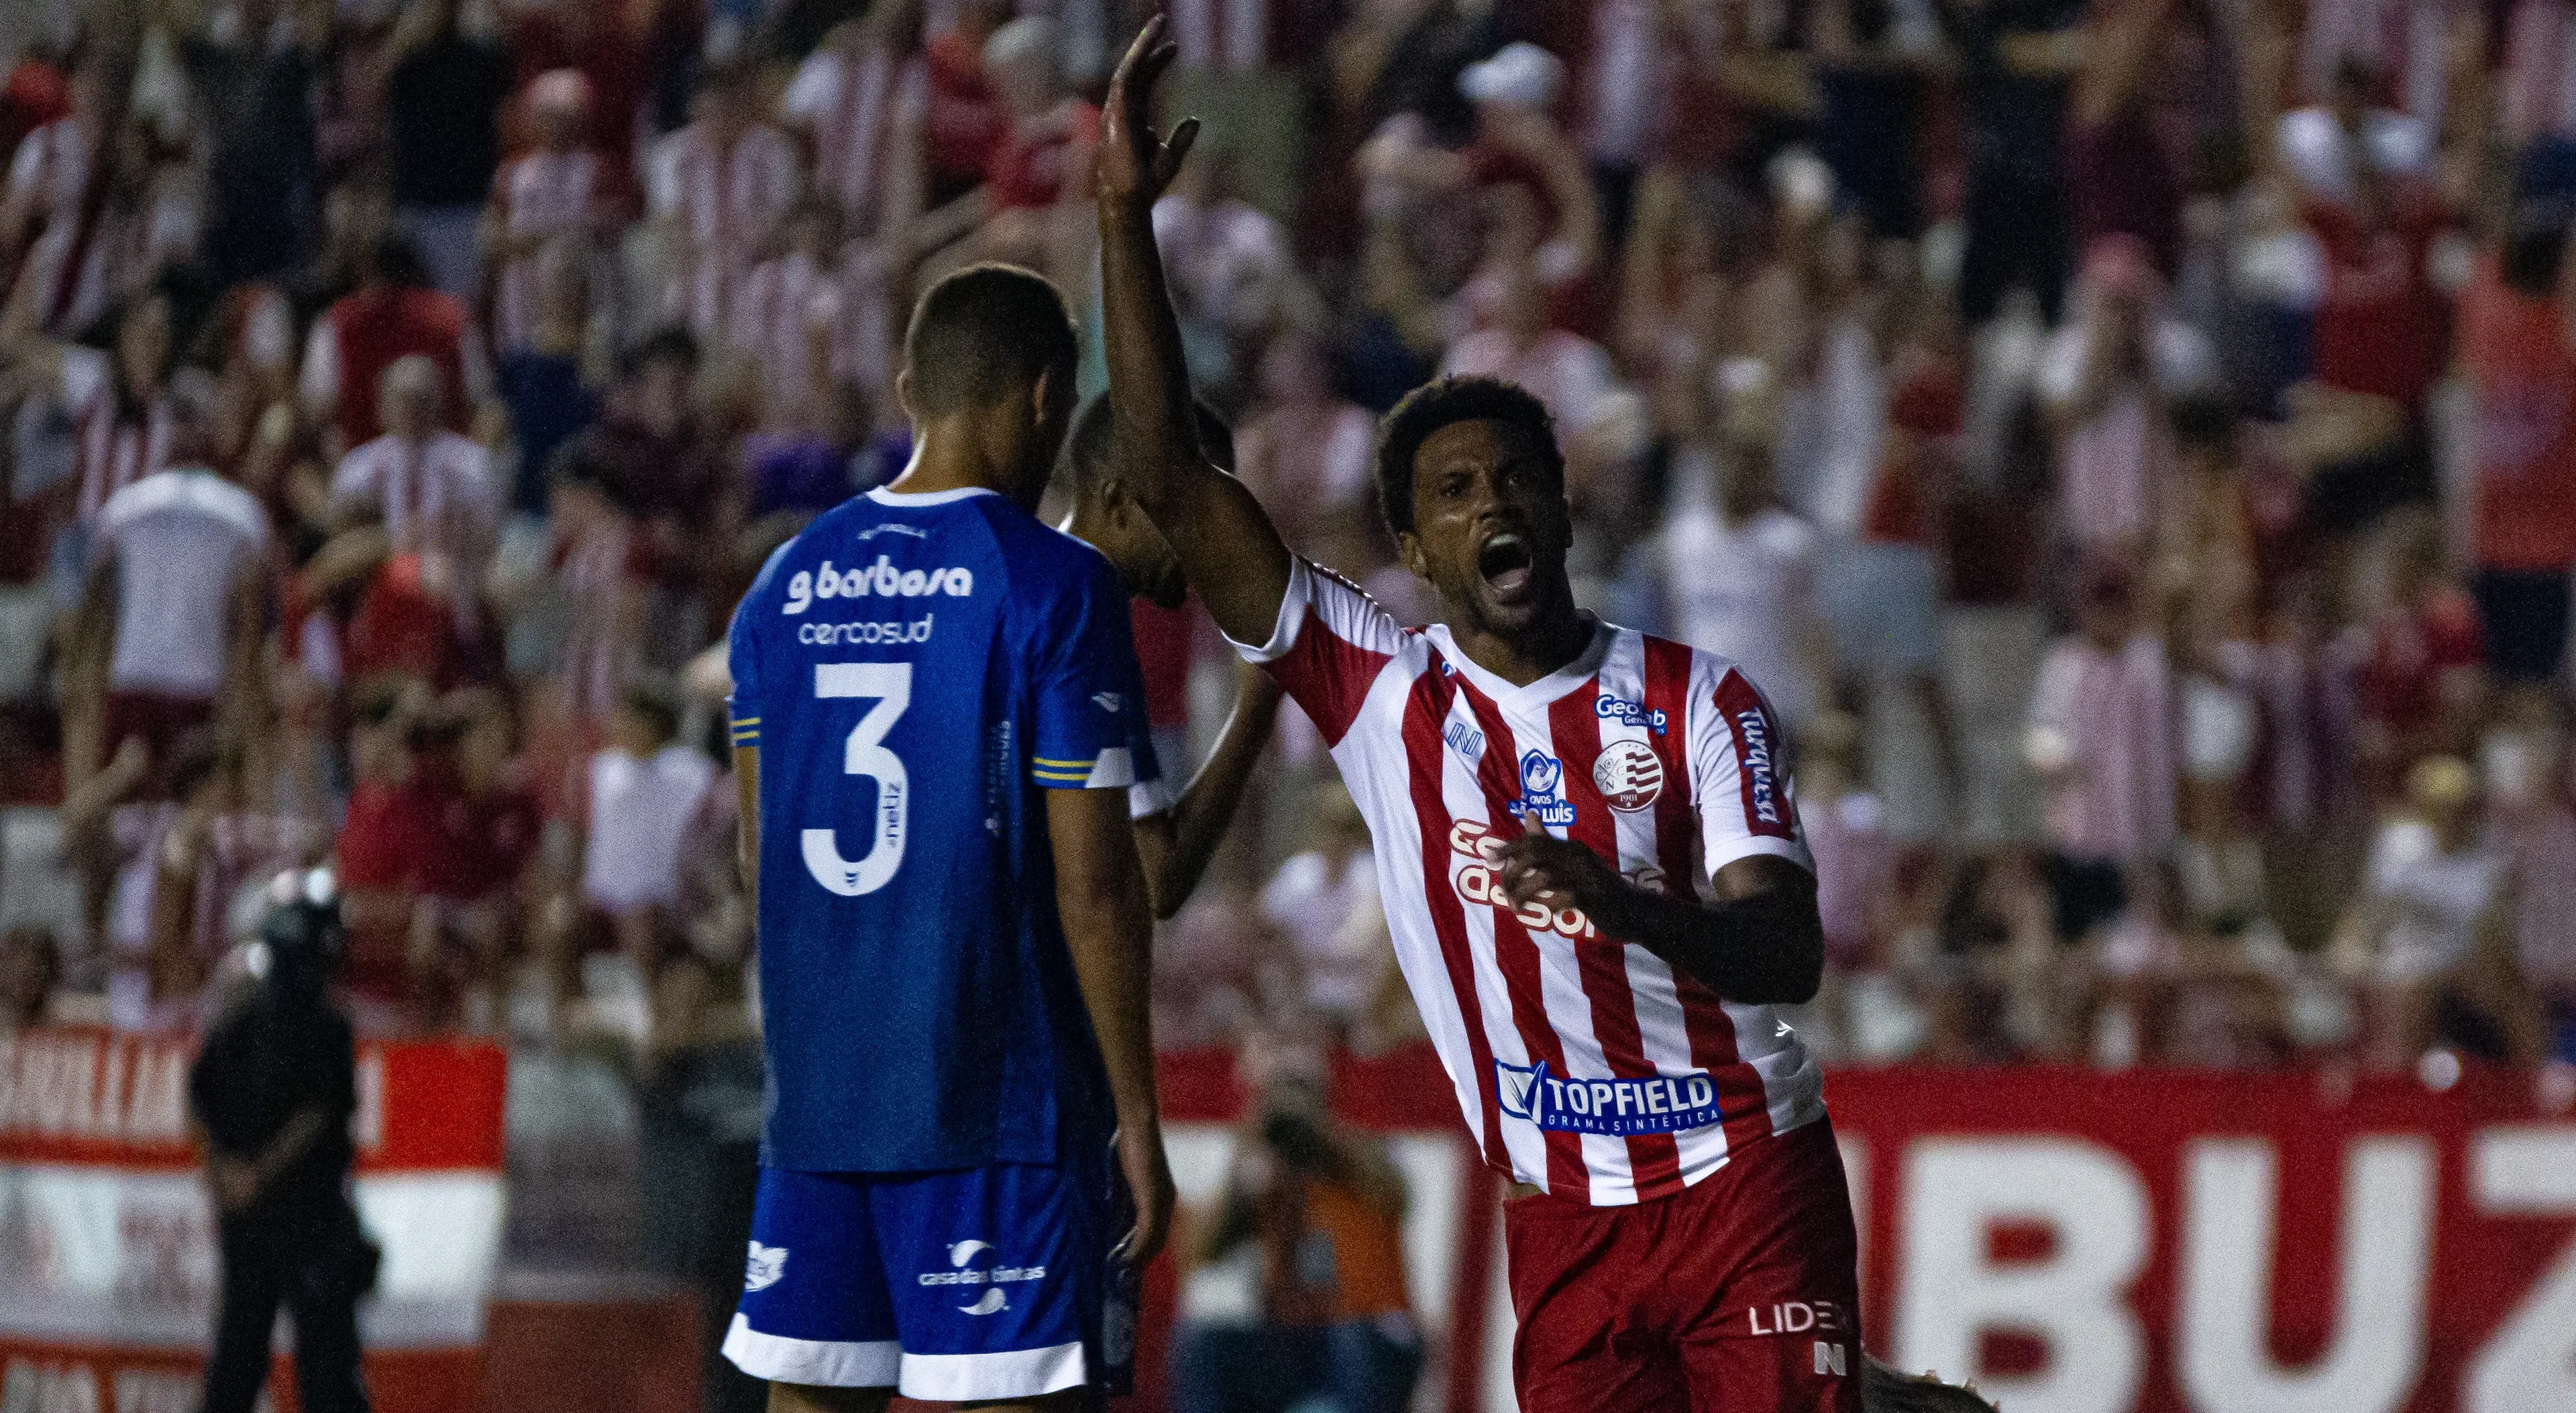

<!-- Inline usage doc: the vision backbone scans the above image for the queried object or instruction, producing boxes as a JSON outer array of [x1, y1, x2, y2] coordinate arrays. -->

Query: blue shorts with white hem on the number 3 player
[[724, 1163, 1136, 1403]]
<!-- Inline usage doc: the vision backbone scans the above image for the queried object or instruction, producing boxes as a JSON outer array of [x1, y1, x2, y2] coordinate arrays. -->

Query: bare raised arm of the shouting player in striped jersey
[[1097, 15, 1288, 642]]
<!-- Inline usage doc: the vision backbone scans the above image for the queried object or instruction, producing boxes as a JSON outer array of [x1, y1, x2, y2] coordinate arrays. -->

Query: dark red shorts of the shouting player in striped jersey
[[1502, 1122, 1860, 1413]]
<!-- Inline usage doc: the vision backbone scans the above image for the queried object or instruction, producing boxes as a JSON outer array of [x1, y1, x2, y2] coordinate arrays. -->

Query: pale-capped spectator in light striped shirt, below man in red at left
[[330, 356, 502, 619]]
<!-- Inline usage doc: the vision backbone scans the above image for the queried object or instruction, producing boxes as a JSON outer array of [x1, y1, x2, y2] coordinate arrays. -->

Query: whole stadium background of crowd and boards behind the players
[[0, 0, 2576, 1413]]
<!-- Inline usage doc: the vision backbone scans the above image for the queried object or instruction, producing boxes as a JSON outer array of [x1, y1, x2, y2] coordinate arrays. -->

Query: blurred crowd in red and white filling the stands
[[0, 0, 2576, 1114]]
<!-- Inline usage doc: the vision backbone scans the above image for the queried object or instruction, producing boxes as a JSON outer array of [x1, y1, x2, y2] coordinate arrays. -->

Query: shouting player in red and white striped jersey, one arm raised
[[1100, 21, 1862, 1413]]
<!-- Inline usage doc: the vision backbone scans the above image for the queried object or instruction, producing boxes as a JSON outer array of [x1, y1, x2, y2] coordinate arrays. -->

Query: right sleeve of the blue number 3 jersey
[[1028, 557, 1162, 789]]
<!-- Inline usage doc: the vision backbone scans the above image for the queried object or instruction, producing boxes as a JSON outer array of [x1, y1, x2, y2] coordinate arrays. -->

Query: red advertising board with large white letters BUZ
[[1165, 1052, 2576, 1413]]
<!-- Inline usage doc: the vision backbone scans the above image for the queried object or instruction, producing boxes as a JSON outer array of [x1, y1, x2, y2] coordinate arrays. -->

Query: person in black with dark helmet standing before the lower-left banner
[[188, 869, 381, 1413]]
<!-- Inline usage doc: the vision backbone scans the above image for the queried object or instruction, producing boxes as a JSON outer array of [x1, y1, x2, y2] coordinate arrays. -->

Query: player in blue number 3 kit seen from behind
[[724, 266, 1172, 1413]]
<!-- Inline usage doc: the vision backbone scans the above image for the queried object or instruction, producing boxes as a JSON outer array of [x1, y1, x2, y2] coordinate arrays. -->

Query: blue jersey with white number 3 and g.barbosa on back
[[732, 490, 1138, 1173]]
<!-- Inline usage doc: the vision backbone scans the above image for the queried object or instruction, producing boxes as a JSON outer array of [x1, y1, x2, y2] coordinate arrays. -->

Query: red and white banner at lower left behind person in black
[[0, 1029, 507, 1413]]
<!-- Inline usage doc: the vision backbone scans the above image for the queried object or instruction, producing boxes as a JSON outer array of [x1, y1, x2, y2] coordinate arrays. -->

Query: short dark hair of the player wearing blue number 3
[[904, 266, 1074, 418]]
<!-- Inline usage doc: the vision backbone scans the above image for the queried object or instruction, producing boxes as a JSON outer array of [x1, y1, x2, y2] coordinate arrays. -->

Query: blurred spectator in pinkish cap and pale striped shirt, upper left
[[484, 70, 616, 358]]
